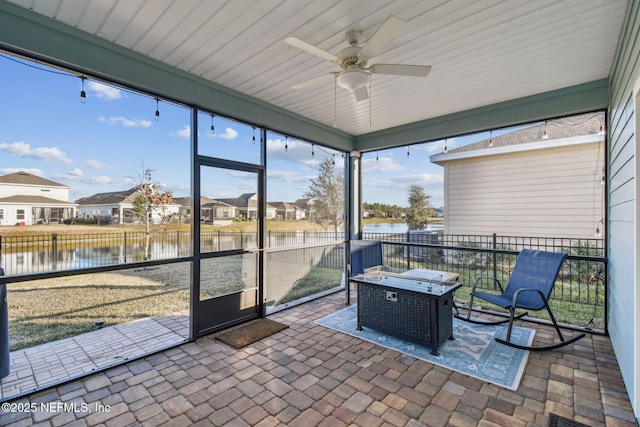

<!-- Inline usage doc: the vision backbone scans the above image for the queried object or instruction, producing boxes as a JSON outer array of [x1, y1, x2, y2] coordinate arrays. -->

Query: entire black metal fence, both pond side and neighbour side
[[0, 231, 607, 330]]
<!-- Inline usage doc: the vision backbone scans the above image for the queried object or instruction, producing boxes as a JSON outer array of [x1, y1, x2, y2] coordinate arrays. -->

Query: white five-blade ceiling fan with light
[[284, 16, 431, 101]]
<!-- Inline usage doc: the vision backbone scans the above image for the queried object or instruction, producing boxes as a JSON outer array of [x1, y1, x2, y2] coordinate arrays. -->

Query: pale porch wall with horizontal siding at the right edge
[[607, 1, 640, 419]]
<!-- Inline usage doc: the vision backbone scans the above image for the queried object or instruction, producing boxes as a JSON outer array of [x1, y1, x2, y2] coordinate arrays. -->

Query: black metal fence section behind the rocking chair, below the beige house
[[367, 233, 607, 331]]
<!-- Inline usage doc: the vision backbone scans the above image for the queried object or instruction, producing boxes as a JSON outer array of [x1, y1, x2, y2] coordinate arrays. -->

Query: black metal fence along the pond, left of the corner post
[[0, 231, 344, 275]]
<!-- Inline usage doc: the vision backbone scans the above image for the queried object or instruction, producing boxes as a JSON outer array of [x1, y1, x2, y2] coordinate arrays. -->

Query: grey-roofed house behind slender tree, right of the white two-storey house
[[76, 187, 180, 224]]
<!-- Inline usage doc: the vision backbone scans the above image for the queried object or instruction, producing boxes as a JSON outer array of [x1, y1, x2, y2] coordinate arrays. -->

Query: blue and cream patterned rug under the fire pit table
[[316, 305, 535, 390]]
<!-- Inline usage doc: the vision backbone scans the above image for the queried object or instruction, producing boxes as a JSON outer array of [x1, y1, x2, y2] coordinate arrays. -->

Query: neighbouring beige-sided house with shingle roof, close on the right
[[431, 112, 605, 239]]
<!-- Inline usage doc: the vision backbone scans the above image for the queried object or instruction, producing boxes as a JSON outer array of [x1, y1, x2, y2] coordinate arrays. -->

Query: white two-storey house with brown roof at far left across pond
[[0, 171, 76, 225]]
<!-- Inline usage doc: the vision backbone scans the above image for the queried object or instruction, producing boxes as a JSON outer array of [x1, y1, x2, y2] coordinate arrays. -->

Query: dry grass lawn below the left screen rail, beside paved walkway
[[7, 263, 189, 351]]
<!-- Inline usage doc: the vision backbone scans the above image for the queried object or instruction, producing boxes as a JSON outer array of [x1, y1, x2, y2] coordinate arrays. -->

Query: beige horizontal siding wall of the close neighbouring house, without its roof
[[444, 141, 605, 239]]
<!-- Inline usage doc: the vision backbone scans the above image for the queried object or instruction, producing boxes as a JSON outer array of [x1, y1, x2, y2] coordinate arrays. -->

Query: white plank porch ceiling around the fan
[[6, 0, 628, 135]]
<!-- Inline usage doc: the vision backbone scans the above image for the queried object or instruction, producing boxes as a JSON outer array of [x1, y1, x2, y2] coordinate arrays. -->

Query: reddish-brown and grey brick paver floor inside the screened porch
[[0, 294, 637, 427]]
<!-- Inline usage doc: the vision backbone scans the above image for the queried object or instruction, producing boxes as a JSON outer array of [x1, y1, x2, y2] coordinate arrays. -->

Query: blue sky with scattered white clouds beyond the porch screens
[[0, 54, 500, 206]]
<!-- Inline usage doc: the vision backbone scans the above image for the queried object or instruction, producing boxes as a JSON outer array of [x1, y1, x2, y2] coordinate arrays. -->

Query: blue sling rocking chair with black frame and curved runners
[[456, 249, 585, 350]]
